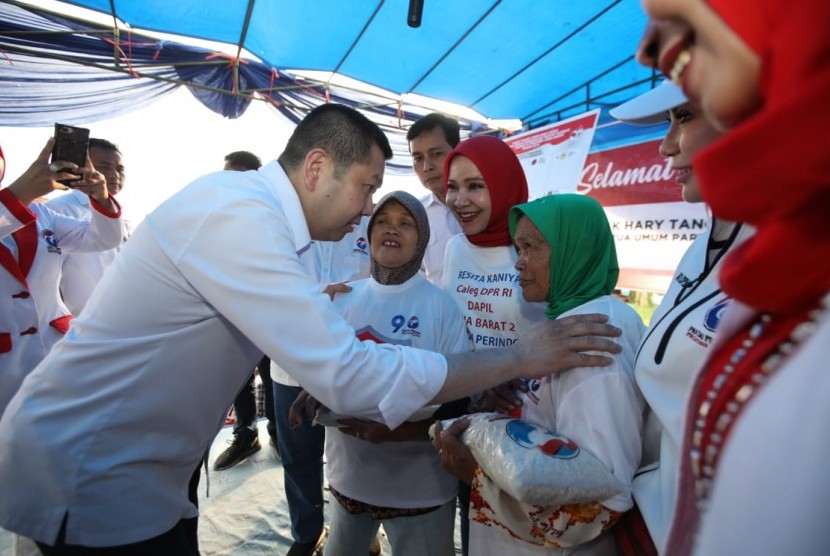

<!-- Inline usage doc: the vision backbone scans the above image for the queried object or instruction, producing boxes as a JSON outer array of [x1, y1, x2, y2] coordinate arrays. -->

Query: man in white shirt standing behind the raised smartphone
[[46, 138, 130, 316]]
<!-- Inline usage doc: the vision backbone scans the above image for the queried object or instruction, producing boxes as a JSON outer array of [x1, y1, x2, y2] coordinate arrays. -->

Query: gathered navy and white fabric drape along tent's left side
[[0, 2, 483, 173]]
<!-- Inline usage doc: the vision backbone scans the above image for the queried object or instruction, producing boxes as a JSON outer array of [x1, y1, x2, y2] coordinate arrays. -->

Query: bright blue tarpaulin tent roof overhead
[[3, 0, 654, 127]]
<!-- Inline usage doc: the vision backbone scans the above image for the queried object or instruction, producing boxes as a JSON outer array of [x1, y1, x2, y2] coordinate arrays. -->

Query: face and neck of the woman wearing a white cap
[[660, 104, 721, 203]]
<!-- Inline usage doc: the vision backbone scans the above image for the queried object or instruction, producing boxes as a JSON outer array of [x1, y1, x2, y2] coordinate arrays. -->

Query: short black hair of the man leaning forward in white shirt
[[279, 104, 392, 178]]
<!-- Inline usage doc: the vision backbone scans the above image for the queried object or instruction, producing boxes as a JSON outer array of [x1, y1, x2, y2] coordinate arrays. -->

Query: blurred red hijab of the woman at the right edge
[[695, 0, 830, 313]]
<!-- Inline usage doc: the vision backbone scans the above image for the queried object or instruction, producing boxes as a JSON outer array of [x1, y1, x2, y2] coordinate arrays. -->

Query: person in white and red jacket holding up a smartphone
[[0, 139, 121, 415]]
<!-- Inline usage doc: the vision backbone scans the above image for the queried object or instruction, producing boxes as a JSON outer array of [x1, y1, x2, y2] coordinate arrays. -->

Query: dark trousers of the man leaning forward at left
[[37, 465, 201, 556]]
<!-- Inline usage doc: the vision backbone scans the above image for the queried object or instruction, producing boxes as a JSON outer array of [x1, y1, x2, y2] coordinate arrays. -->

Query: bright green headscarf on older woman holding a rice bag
[[508, 194, 620, 319]]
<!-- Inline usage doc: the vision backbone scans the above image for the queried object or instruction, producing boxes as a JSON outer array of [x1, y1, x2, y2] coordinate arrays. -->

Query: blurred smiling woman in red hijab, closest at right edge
[[638, 0, 830, 555]]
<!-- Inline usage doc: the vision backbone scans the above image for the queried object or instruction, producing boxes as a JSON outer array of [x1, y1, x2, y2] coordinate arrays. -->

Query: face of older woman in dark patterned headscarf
[[370, 200, 418, 268]]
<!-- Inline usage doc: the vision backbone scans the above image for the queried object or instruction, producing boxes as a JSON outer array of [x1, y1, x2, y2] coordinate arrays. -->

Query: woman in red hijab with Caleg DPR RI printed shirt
[[441, 136, 546, 554]]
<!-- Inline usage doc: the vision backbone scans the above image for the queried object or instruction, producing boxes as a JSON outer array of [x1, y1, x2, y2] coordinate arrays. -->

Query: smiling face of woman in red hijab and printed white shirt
[[447, 155, 493, 236]]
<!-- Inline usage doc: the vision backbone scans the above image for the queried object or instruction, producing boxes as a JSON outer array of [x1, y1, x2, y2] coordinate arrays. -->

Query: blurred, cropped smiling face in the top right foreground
[[637, 0, 761, 131]]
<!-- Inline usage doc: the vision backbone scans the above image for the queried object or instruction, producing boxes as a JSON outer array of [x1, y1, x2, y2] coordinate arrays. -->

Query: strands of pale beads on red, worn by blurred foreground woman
[[690, 293, 830, 507]]
